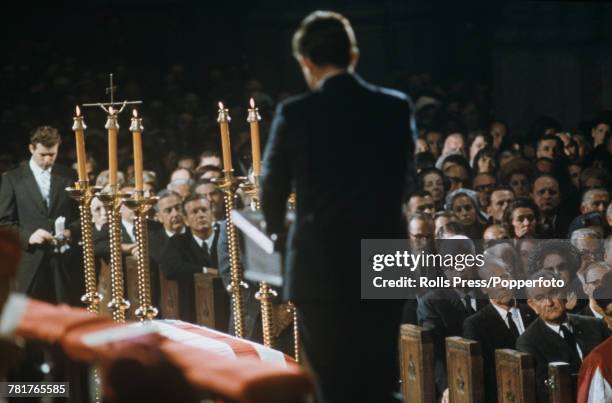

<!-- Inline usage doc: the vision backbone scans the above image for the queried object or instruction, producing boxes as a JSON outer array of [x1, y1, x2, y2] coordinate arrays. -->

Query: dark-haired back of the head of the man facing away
[[293, 11, 357, 68]]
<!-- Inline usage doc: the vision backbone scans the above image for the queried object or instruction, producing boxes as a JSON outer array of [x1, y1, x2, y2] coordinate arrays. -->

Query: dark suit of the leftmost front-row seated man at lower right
[[417, 288, 489, 395]]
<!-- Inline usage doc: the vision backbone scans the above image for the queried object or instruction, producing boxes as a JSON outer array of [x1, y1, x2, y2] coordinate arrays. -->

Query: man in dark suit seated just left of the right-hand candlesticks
[[161, 194, 218, 322]]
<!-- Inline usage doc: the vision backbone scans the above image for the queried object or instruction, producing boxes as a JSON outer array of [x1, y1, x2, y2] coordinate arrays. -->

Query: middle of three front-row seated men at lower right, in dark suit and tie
[[463, 257, 536, 402]]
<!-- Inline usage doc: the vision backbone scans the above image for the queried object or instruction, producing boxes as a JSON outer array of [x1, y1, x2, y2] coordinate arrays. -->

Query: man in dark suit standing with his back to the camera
[[261, 11, 414, 402]]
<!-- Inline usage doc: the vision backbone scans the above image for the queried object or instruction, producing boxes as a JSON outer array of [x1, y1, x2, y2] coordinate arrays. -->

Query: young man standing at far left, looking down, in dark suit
[[0, 126, 80, 303]]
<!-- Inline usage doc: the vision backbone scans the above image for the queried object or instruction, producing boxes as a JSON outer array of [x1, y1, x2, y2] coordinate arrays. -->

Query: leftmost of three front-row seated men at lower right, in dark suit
[[417, 235, 487, 396]]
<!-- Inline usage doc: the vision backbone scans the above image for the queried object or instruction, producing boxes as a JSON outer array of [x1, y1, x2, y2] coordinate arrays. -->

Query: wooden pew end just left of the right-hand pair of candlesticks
[[193, 273, 230, 333]]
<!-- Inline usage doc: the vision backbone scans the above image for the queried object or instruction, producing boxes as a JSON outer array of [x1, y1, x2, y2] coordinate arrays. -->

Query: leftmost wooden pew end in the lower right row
[[400, 324, 436, 403]]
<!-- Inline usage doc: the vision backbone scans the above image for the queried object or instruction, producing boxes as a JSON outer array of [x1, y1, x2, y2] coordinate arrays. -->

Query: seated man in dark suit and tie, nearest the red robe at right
[[516, 270, 608, 403]]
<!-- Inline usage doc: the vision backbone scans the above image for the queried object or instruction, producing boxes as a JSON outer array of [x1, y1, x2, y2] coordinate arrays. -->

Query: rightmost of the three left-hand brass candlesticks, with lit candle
[[124, 111, 157, 322]]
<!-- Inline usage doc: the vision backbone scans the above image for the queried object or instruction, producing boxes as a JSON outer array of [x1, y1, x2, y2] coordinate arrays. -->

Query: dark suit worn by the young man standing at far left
[[0, 163, 82, 302]]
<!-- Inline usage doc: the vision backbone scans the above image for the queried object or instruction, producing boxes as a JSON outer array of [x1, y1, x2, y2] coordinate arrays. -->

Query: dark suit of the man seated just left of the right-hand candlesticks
[[161, 230, 218, 322]]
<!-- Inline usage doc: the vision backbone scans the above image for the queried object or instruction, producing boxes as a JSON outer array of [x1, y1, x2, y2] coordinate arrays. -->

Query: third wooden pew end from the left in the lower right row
[[495, 349, 536, 403]]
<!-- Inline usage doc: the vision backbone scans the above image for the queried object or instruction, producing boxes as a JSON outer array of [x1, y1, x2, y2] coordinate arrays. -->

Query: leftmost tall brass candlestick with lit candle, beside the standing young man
[[66, 106, 102, 313]]
